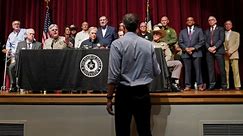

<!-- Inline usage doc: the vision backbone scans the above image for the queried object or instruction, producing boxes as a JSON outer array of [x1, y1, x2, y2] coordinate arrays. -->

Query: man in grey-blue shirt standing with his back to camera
[[106, 14, 161, 136]]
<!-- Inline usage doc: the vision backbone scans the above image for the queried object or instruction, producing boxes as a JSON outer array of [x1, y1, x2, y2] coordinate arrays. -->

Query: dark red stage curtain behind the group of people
[[0, 0, 243, 86]]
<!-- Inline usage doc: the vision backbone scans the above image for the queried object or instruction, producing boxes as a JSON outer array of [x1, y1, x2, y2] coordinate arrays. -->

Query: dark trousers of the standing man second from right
[[206, 52, 227, 88]]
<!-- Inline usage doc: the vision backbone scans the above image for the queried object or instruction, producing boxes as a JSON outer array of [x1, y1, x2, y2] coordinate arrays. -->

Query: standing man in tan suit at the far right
[[224, 20, 241, 90]]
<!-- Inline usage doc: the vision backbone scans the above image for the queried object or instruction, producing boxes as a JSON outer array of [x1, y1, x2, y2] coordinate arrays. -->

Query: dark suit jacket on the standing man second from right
[[205, 26, 225, 54]]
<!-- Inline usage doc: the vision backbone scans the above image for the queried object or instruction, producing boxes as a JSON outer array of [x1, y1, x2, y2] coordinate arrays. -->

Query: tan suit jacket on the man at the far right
[[224, 31, 240, 59]]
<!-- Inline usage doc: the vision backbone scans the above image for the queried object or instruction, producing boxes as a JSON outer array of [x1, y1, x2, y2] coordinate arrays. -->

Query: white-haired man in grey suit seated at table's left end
[[9, 28, 41, 91]]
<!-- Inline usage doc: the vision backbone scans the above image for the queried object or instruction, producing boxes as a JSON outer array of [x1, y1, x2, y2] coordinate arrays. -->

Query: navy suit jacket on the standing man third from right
[[179, 26, 204, 58]]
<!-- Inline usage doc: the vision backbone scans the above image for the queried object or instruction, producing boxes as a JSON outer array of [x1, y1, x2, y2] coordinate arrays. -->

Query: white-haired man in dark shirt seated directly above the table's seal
[[80, 27, 104, 49]]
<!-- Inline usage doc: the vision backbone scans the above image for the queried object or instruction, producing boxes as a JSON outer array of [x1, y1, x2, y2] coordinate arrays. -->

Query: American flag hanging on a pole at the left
[[42, 7, 51, 47]]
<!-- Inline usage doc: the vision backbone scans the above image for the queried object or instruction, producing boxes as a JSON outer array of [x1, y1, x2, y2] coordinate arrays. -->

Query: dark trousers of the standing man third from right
[[183, 57, 203, 87]]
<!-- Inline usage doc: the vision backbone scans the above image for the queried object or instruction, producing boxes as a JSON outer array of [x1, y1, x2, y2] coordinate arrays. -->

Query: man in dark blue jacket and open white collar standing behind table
[[97, 16, 117, 48]]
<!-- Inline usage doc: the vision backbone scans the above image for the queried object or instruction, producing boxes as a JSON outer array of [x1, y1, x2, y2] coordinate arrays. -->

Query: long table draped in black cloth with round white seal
[[17, 49, 169, 92]]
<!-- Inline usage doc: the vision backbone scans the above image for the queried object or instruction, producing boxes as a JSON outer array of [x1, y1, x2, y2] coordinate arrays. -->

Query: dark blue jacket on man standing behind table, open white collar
[[96, 26, 117, 48]]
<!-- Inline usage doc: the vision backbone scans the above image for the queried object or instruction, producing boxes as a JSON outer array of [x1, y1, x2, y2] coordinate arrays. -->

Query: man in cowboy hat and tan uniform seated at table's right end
[[152, 26, 182, 92]]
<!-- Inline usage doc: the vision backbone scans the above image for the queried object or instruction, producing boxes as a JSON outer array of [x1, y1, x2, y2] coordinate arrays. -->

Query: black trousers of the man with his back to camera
[[115, 85, 152, 136]]
